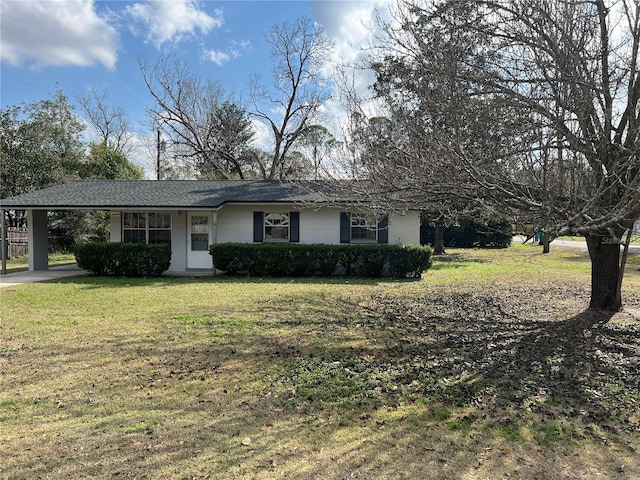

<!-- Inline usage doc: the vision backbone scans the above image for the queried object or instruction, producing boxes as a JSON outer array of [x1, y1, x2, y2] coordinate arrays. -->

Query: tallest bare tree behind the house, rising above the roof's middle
[[250, 17, 331, 179]]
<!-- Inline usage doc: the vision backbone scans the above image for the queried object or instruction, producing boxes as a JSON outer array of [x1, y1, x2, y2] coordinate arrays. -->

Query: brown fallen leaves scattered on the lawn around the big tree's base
[[265, 285, 640, 438]]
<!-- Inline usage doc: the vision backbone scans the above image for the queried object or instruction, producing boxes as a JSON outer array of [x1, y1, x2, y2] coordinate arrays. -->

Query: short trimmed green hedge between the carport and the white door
[[73, 242, 171, 277]]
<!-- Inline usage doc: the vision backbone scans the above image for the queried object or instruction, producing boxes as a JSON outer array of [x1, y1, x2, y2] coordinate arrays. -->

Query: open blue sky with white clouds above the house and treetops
[[0, 0, 390, 175]]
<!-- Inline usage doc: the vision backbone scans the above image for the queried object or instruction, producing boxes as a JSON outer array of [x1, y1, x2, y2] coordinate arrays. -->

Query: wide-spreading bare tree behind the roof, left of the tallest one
[[140, 56, 254, 179]]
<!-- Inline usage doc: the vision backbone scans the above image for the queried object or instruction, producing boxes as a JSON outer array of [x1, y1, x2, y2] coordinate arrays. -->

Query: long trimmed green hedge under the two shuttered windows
[[209, 243, 431, 278]]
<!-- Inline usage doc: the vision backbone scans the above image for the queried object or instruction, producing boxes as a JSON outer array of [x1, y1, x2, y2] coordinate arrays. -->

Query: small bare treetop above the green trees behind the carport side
[[78, 89, 133, 156]]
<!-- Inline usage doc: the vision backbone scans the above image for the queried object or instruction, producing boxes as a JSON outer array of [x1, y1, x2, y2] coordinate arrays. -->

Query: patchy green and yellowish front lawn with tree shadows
[[0, 245, 640, 479]]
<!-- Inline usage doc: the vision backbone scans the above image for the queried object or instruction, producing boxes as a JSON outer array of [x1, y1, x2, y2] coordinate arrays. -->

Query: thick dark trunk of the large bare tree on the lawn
[[586, 235, 622, 312]]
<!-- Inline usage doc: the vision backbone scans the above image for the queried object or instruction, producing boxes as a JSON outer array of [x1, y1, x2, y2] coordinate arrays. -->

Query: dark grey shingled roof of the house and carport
[[0, 180, 338, 210]]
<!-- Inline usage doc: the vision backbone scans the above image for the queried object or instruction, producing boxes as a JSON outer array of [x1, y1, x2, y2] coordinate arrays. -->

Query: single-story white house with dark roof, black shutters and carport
[[0, 180, 420, 272]]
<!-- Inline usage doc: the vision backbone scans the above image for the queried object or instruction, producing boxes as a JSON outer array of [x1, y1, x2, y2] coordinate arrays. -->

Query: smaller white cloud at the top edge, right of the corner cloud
[[125, 0, 224, 48]]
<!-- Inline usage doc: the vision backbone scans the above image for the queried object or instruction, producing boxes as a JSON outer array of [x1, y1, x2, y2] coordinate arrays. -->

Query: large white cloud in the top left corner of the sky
[[0, 0, 119, 69]]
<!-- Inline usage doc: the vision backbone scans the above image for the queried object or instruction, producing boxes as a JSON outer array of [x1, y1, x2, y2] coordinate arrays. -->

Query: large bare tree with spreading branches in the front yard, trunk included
[[350, 0, 640, 311]]
